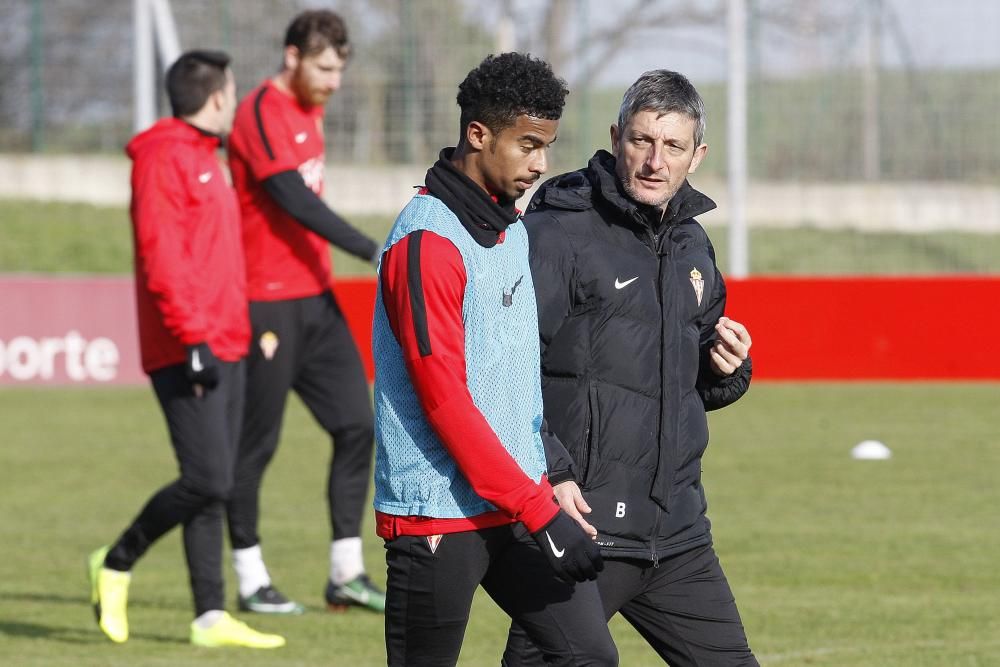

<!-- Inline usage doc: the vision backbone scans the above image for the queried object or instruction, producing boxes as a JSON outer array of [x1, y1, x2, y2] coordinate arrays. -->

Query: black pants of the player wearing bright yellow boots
[[105, 362, 246, 615]]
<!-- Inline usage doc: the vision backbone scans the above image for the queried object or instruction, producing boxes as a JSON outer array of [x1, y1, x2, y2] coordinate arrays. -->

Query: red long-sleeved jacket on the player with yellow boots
[[126, 118, 250, 373]]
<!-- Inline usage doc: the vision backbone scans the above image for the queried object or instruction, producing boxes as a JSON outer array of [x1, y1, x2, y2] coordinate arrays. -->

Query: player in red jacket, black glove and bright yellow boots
[[88, 51, 285, 648]]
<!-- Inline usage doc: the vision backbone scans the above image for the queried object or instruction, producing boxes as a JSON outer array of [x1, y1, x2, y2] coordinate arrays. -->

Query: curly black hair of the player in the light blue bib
[[458, 53, 569, 139]]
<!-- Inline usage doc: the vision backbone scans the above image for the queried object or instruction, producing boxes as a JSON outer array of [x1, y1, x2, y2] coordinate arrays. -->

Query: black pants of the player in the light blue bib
[[385, 523, 618, 667]]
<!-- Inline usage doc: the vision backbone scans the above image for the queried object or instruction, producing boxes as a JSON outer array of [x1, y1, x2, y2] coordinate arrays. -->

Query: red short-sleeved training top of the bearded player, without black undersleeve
[[229, 80, 332, 301]]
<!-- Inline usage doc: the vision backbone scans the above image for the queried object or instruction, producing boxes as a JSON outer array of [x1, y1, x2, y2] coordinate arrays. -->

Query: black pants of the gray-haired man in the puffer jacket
[[504, 545, 758, 667]]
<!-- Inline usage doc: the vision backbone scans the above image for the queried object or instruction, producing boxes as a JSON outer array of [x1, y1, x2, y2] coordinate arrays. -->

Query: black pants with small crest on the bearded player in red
[[226, 292, 374, 549]]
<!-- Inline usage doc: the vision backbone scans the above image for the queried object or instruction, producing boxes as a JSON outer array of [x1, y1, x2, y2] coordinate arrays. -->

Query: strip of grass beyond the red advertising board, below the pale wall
[[0, 197, 1000, 276]]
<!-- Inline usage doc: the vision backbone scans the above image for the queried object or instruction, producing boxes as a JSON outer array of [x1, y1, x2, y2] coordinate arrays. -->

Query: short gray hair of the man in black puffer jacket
[[618, 69, 705, 146]]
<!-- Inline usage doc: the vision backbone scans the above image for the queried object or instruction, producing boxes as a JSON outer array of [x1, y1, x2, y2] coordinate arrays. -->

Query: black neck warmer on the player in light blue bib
[[424, 148, 518, 248]]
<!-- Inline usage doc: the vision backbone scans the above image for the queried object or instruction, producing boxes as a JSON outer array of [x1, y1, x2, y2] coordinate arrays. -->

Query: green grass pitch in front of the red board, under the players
[[0, 383, 1000, 667]]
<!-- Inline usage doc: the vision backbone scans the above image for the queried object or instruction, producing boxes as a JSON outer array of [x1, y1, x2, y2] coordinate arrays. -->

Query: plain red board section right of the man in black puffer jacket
[[726, 276, 1000, 380]]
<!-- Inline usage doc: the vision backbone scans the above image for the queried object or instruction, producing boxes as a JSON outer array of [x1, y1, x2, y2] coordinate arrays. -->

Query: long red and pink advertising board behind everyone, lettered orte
[[0, 276, 1000, 385]]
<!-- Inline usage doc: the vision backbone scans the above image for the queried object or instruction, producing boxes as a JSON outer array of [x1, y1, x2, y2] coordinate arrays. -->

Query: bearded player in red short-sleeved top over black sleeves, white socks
[[228, 10, 385, 614]]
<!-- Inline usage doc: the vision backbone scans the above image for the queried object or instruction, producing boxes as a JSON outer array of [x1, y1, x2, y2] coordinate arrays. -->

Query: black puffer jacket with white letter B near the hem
[[524, 151, 750, 562]]
